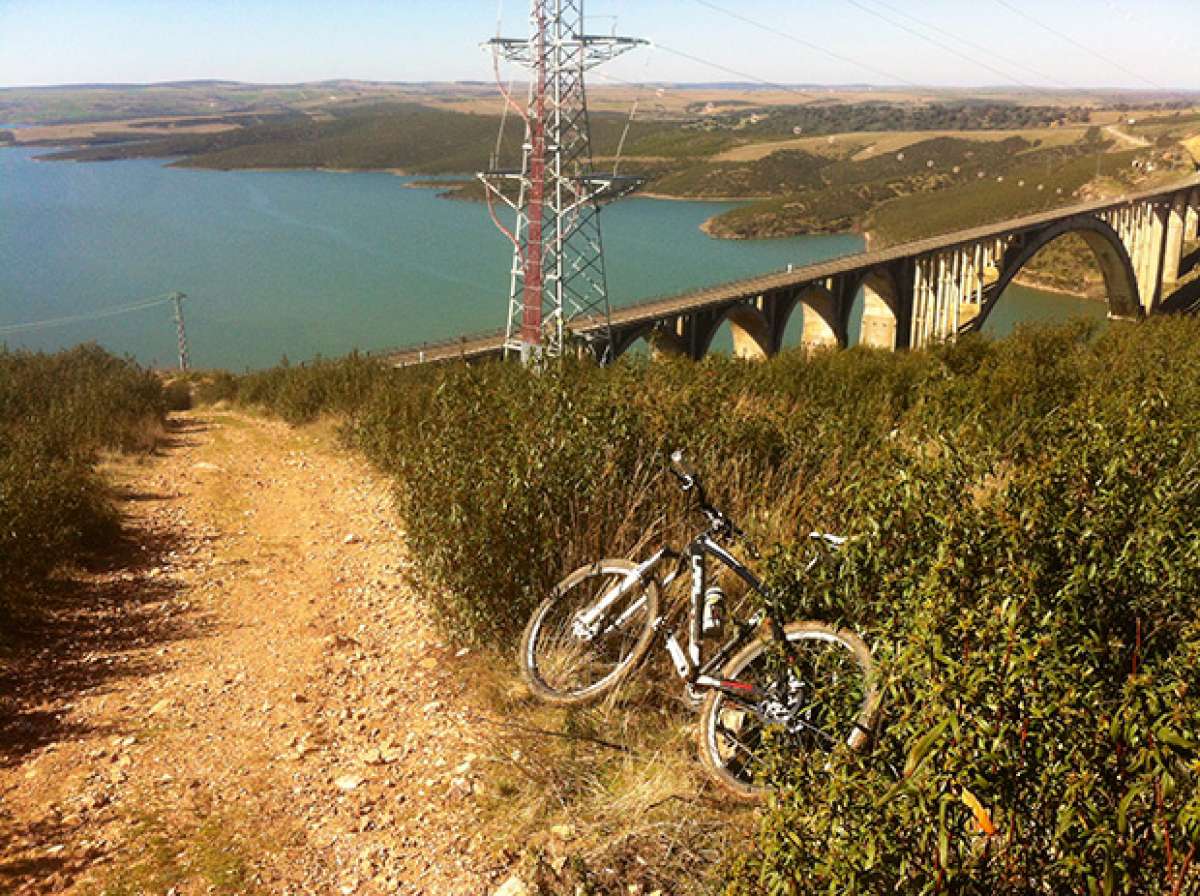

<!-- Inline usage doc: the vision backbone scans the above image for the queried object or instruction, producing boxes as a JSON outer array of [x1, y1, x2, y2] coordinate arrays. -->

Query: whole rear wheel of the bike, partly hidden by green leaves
[[700, 623, 880, 800]]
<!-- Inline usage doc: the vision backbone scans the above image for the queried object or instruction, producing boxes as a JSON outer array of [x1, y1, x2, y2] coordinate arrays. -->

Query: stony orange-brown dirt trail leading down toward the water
[[0, 413, 503, 895]]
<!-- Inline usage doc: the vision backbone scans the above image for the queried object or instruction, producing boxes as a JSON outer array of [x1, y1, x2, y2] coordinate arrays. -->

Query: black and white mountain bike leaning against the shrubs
[[520, 451, 880, 800]]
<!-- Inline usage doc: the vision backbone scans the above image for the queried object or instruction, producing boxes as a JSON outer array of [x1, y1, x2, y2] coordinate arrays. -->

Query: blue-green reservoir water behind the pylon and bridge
[[0, 149, 1104, 369]]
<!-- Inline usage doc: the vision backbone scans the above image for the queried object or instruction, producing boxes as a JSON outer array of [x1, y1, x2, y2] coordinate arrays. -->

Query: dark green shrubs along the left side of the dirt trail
[[0, 345, 166, 611]]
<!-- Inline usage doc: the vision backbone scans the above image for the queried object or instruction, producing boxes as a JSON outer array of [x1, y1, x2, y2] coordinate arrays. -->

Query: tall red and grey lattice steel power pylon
[[479, 0, 646, 362]]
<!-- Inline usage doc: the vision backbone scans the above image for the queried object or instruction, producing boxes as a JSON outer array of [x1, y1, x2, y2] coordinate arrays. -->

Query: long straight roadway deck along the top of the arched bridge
[[380, 176, 1200, 367]]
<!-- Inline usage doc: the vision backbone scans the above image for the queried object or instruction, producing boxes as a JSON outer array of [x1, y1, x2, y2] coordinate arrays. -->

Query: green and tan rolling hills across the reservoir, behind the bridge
[[30, 101, 1200, 243]]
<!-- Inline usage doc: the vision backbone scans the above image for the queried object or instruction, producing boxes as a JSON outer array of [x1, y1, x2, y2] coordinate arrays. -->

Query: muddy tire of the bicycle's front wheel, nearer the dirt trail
[[518, 558, 659, 705]]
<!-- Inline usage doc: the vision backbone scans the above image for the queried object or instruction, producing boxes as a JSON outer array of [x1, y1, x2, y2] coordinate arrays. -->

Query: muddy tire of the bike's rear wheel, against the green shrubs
[[698, 621, 881, 802]]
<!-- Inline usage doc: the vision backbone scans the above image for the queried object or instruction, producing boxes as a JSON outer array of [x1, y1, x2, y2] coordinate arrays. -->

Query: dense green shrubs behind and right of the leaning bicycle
[[201, 319, 1200, 896]]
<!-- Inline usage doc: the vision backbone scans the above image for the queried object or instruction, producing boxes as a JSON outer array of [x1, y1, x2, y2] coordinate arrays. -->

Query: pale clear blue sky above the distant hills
[[0, 0, 1200, 89]]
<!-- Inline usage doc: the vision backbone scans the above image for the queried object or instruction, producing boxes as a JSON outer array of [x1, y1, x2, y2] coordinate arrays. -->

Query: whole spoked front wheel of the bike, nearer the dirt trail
[[521, 559, 659, 704]]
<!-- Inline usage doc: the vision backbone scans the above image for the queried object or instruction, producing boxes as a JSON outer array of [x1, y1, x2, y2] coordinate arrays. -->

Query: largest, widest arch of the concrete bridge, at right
[[973, 215, 1144, 330]]
